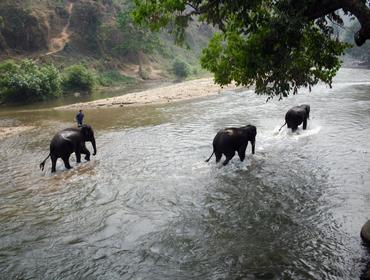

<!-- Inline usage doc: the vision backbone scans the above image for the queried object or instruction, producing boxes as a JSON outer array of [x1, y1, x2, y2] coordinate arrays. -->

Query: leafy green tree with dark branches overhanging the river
[[133, 0, 370, 98]]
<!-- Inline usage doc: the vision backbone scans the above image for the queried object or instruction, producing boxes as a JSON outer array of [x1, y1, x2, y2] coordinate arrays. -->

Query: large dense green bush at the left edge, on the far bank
[[0, 59, 60, 103]]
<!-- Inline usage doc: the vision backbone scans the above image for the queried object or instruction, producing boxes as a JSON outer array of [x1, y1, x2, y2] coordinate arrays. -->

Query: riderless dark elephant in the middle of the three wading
[[206, 125, 257, 165]]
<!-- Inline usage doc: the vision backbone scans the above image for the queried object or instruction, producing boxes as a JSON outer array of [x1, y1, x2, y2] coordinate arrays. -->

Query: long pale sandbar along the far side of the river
[[55, 78, 237, 110]]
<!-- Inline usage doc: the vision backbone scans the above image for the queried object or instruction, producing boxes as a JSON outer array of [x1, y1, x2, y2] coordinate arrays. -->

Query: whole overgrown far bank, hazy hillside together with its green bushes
[[0, 0, 213, 102]]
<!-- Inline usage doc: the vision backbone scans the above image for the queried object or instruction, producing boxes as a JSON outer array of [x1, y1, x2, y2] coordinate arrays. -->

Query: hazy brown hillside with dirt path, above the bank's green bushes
[[0, 0, 212, 80]]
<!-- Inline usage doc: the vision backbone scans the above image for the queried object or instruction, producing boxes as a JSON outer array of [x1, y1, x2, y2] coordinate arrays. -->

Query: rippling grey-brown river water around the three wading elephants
[[0, 69, 370, 280]]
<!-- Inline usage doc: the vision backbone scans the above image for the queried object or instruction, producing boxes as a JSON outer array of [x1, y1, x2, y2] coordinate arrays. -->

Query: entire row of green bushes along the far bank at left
[[0, 59, 112, 103]]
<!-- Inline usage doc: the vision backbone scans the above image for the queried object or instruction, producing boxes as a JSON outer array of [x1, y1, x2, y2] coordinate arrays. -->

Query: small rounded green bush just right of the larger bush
[[62, 64, 96, 92]]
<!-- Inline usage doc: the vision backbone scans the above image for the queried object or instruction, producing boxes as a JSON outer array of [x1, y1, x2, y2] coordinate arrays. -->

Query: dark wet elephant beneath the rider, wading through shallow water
[[40, 125, 96, 172]]
